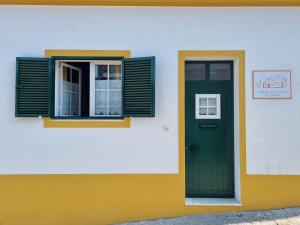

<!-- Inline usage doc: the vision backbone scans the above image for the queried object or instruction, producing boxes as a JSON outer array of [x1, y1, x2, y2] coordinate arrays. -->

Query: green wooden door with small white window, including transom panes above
[[185, 61, 234, 198]]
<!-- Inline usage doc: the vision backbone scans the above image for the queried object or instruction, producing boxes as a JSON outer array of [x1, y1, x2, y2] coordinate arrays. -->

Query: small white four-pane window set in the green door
[[195, 94, 221, 119]]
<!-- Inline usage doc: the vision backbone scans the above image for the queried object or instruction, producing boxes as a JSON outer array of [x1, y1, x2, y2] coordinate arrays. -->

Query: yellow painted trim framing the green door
[[178, 51, 246, 201]]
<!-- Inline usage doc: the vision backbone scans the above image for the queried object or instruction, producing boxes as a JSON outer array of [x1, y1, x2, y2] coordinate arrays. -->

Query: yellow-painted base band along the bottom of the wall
[[0, 175, 300, 225]]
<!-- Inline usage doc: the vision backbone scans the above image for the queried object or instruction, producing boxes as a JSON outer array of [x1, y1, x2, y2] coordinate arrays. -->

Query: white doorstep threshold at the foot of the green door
[[185, 198, 242, 206]]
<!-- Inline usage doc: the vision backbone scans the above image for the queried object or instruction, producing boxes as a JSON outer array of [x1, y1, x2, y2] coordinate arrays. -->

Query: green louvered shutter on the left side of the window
[[16, 58, 51, 117]]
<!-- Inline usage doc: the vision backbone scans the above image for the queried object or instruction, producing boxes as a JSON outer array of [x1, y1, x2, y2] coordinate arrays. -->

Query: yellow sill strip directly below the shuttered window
[[44, 117, 130, 128]]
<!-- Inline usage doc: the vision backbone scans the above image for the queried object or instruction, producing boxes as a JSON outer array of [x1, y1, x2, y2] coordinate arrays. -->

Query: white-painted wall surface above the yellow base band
[[0, 6, 300, 174]]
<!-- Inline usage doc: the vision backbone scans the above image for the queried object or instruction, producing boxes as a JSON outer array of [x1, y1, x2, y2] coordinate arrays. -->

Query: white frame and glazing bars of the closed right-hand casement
[[90, 60, 123, 117]]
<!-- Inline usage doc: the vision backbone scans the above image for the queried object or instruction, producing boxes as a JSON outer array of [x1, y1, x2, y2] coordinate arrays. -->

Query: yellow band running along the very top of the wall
[[0, 0, 300, 6]]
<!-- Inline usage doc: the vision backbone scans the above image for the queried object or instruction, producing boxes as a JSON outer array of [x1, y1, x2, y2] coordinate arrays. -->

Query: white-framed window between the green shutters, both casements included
[[55, 60, 123, 118]]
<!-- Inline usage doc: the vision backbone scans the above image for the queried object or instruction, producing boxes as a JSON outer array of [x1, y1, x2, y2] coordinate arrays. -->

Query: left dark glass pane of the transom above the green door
[[185, 61, 206, 80]]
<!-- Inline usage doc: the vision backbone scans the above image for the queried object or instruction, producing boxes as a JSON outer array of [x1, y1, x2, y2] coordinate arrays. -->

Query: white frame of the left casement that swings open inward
[[54, 61, 82, 117]]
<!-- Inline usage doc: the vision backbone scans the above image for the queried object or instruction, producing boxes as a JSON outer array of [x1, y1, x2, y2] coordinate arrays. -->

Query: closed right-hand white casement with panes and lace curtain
[[90, 60, 123, 117]]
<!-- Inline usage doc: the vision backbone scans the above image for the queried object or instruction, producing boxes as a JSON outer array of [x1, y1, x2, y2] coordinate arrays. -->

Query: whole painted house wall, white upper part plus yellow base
[[0, 6, 300, 225]]
